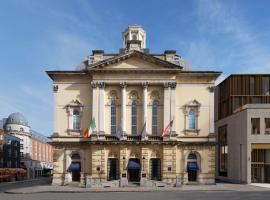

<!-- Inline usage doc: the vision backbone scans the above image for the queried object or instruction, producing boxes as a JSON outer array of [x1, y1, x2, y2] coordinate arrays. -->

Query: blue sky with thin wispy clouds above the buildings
[[0, 0, 270, 136]]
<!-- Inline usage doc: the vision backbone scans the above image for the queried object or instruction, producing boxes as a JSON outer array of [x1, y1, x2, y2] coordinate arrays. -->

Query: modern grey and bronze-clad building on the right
[[215, 74, 270, 183]]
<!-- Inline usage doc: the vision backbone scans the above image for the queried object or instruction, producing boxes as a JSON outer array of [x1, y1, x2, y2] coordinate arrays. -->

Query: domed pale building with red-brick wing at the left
[[4, 113, 53, 179]]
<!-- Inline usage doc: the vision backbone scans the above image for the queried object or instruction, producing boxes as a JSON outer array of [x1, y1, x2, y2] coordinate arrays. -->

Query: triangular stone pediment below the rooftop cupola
[[88, 51, 182, 70]]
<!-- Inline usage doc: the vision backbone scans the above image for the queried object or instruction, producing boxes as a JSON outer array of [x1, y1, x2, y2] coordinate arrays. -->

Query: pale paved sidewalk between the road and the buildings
[[5, 183, 270, 194]]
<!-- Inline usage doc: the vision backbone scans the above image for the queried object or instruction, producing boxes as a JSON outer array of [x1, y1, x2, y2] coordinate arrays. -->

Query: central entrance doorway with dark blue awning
[[128, 158, 141, 182]]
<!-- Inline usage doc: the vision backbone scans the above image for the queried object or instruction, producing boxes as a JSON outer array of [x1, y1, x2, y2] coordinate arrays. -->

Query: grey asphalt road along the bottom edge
[[0, 191, 270, 200]]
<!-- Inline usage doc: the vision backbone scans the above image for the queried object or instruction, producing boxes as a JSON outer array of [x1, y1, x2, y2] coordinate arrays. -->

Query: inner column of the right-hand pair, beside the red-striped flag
[[163, 82, 171, 129]]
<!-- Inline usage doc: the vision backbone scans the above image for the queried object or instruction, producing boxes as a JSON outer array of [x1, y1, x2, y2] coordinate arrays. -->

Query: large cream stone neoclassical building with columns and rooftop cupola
[[47, 25, 220, 187]]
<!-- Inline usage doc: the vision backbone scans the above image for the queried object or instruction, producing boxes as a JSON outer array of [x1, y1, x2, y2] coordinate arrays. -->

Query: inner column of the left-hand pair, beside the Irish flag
[[98, 82, 105, 134]]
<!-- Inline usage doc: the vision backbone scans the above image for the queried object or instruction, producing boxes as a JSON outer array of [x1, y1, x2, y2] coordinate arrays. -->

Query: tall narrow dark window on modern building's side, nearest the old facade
[[218, 125, 228, 176]]
